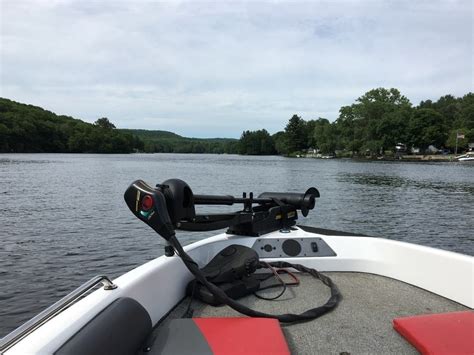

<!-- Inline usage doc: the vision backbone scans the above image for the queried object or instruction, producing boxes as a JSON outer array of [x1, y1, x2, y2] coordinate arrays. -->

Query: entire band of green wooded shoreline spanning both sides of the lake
[[0, 88, 474, 156]]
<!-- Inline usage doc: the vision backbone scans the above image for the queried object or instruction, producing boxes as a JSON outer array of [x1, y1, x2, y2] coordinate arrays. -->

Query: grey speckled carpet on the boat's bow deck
[[155, 272, 468, 355]]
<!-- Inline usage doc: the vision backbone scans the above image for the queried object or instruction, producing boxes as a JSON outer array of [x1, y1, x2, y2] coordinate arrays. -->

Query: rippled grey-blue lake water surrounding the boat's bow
[[0, 154, 474, 336]]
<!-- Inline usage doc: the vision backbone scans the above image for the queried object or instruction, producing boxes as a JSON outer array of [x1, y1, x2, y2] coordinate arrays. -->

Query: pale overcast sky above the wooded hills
[[0, 0, 473, 138]]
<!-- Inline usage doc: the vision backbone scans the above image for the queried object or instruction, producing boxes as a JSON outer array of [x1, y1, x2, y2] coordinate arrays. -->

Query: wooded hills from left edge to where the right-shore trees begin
[[0, 98, 238, 153]]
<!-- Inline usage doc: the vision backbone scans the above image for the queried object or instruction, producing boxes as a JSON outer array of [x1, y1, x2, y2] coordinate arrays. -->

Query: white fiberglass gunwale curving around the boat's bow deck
[[5, 228, 474, 354]]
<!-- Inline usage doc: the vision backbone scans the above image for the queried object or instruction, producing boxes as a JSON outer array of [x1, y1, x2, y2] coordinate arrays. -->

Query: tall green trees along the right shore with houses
[[238, 88, 474, 156]]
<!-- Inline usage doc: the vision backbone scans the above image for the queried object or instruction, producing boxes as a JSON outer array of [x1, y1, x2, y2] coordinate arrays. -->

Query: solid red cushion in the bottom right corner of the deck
[[393, 311, 474, 355]]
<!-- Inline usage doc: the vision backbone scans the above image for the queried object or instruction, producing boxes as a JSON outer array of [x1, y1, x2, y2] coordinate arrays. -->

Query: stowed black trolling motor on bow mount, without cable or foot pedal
[[124, 179, 319, 240]]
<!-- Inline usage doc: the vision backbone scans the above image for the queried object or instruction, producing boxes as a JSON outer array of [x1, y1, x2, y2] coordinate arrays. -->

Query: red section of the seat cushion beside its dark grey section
[[193, 318, 290, 355]]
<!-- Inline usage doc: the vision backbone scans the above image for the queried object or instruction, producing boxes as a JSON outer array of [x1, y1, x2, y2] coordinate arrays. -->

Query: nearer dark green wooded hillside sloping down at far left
[[0, 98, 143, 153]]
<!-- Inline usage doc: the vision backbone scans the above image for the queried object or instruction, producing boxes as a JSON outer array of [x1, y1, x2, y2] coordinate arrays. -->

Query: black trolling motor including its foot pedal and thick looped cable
[[124, 179, 340, 322]]
